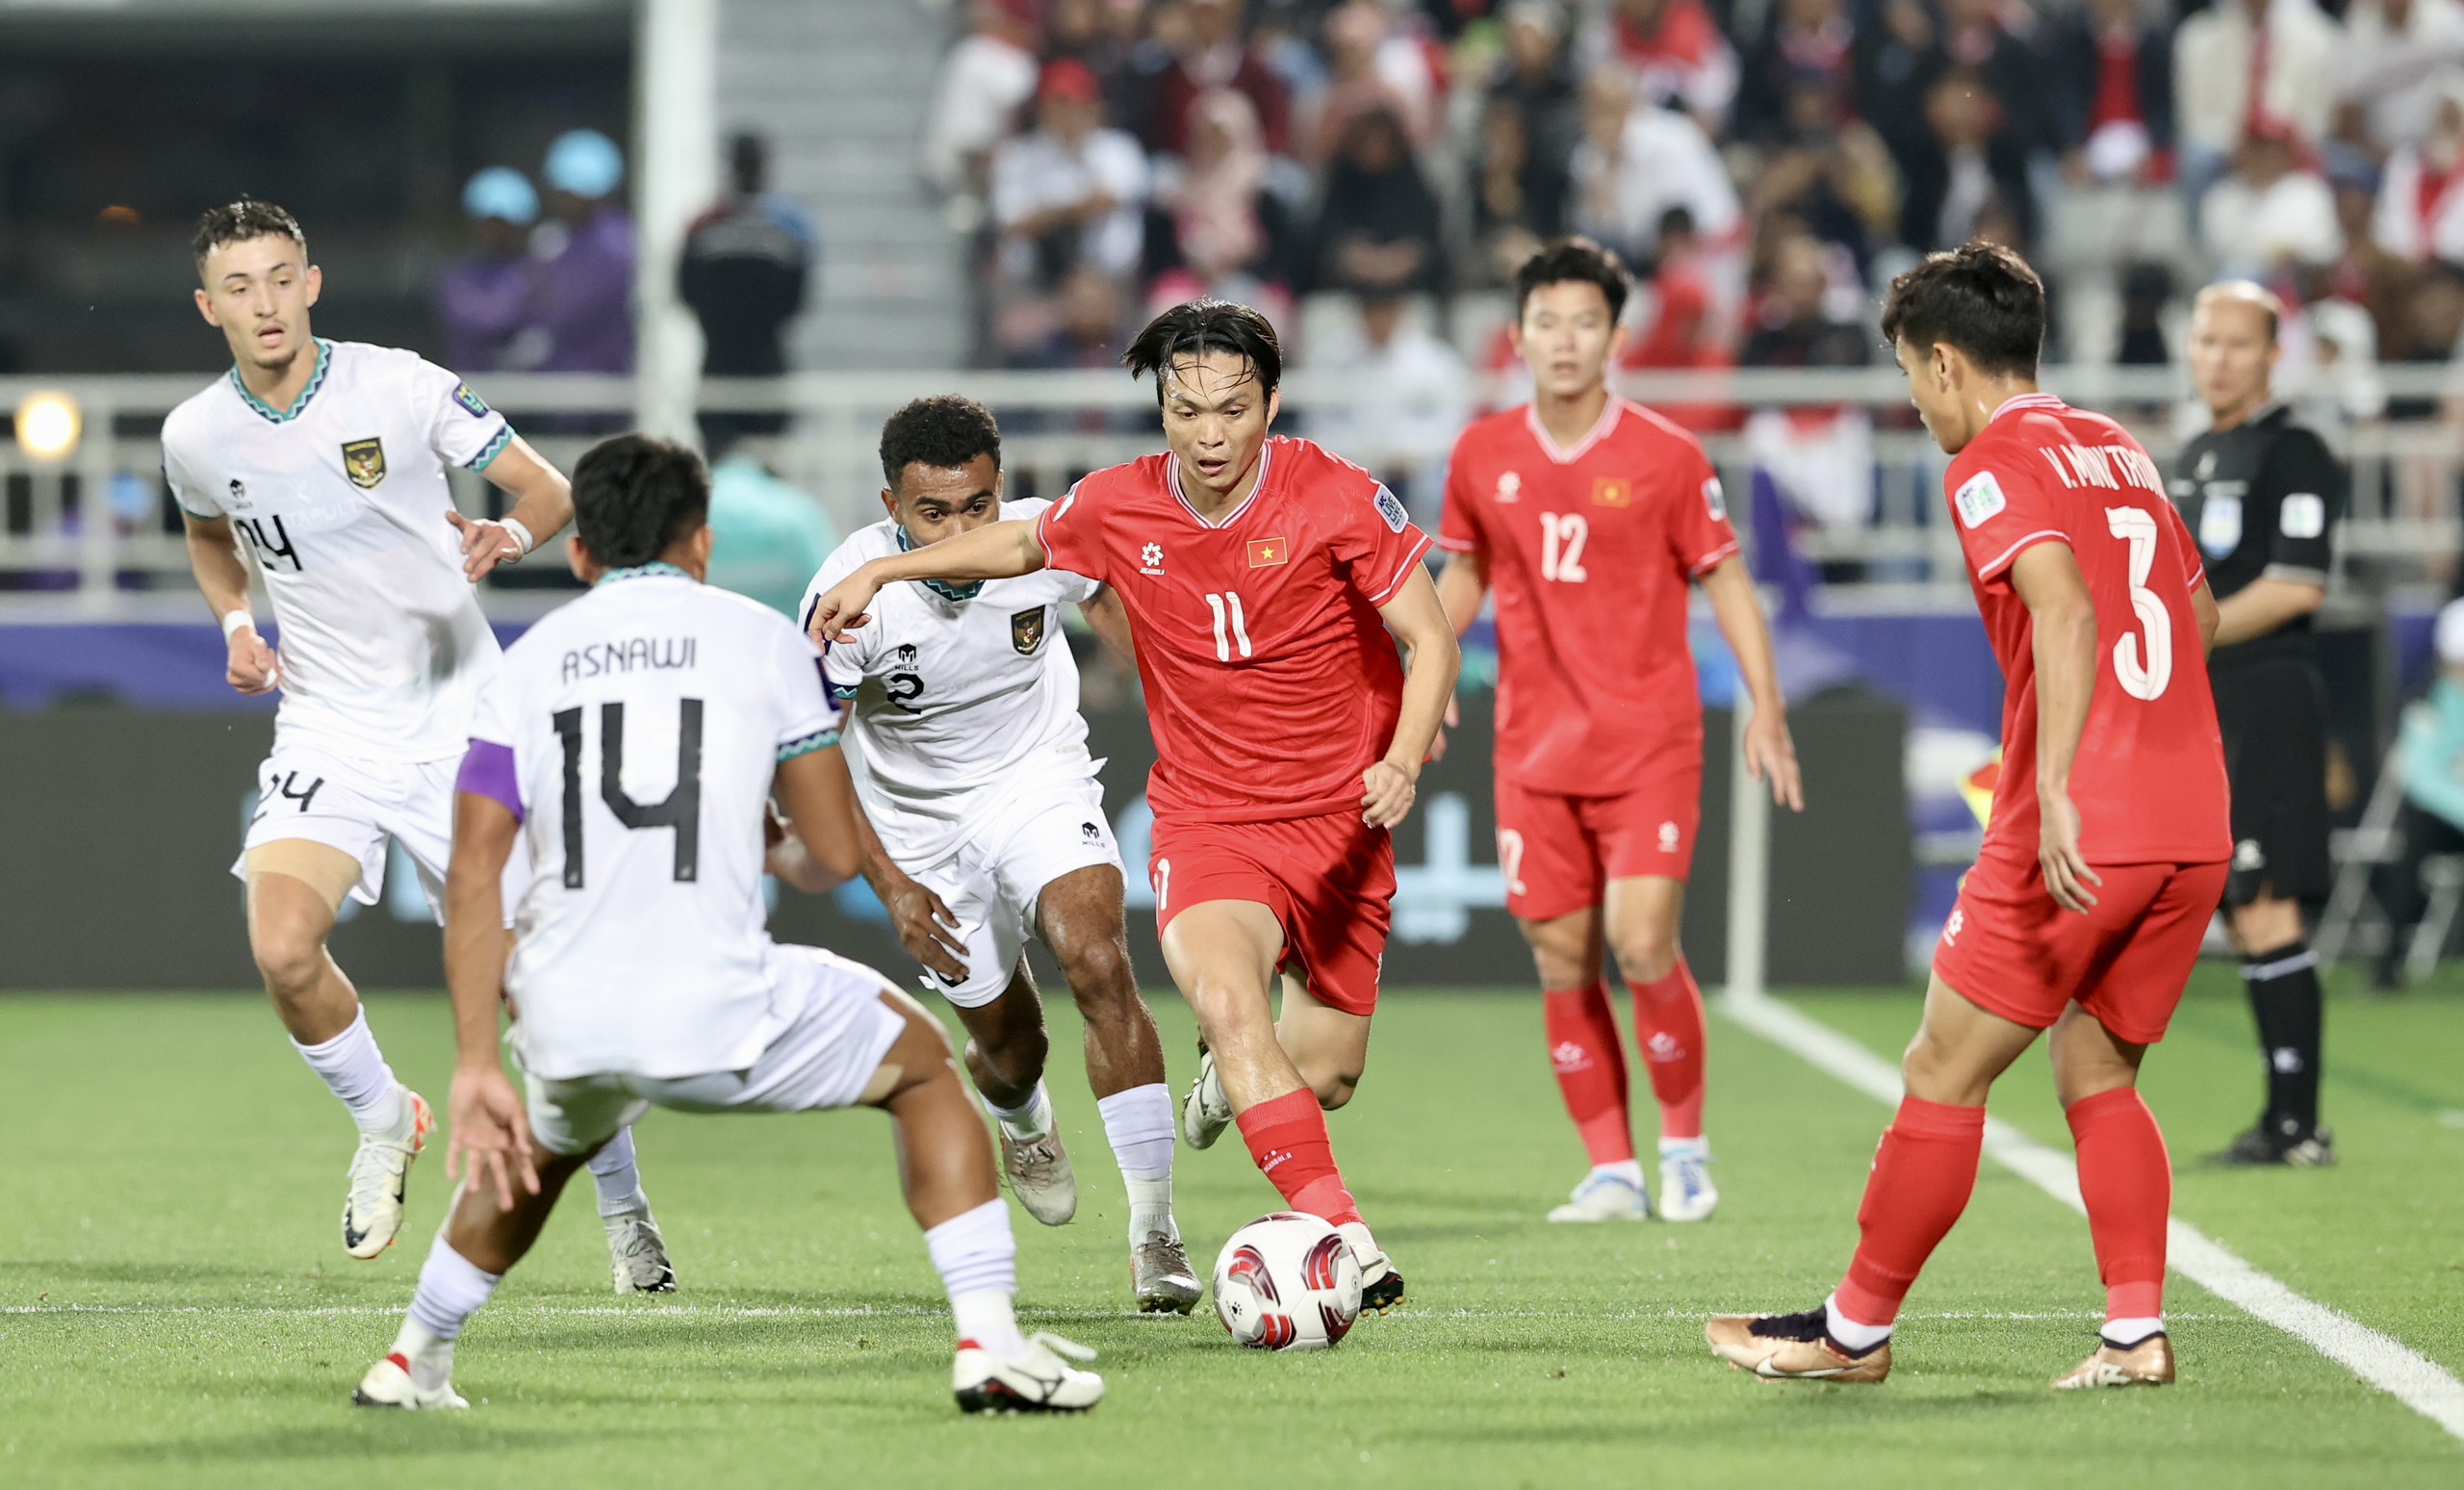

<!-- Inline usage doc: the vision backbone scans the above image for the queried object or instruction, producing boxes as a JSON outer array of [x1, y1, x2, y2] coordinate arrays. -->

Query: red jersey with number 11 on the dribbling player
[[1035, 438, 1429, 823]]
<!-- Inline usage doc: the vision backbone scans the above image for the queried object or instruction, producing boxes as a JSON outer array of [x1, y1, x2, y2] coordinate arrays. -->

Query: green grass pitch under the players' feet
[[0, 968, 2464, 1490]]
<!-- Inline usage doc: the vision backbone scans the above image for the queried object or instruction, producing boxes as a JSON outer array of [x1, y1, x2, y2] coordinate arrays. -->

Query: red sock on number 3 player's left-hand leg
[[1835, 1096, 1986, 1325]]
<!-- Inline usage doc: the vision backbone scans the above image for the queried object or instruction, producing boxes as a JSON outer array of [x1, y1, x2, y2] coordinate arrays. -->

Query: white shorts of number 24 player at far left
[[232, 733, 529, 926]]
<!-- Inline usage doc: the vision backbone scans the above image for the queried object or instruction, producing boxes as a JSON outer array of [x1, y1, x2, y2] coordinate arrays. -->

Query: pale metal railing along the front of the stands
[[0, 367, 2464, 616]]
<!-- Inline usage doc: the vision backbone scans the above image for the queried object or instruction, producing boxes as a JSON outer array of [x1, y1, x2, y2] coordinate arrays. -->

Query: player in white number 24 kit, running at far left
[[163, 199, 675, 1293]]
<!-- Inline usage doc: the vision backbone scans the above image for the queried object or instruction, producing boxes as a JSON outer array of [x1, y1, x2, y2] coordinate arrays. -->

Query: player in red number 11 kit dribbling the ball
[[810, 300, 1461, 1313]]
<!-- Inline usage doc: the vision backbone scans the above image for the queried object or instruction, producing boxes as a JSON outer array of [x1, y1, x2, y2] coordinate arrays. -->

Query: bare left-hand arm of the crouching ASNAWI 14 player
[[446, 783, 540, 1212]]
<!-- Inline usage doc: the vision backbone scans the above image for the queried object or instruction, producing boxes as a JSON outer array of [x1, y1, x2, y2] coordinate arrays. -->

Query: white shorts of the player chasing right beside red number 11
[[910, 776, 1121, 1010]]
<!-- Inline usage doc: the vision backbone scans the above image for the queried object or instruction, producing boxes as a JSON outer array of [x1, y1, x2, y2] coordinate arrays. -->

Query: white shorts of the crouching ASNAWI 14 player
[[512, 946, 907, 1155]]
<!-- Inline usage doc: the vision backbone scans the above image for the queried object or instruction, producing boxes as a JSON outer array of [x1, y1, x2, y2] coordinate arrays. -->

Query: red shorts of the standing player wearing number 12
[[1498, 741, 1703, 921]]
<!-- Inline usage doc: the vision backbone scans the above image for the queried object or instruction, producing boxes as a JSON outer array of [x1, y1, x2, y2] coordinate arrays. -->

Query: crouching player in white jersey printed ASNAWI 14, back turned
[[352, 436, 1104, 1411]]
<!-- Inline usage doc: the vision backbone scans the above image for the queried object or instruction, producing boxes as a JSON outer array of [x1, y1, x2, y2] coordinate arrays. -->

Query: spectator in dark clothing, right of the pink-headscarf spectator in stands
[[1313, 109, 1447, 295]]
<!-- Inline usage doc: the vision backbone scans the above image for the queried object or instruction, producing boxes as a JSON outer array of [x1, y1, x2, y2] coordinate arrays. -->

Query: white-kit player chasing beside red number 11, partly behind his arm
[[806, 397, 1200, 1315]]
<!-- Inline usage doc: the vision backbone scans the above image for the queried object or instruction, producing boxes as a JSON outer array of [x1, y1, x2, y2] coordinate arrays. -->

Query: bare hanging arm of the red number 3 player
[[2011, 544, 2104, 916]]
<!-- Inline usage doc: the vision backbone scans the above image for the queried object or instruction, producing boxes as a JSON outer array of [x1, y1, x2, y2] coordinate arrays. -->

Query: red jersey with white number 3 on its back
[[1941, 394, 2232, 864]]
